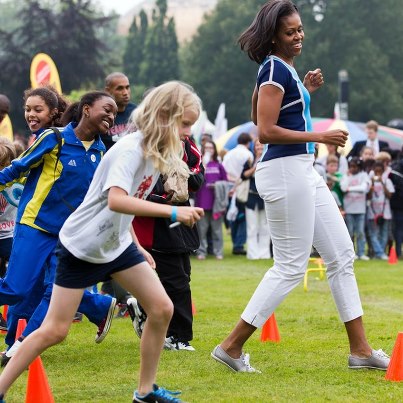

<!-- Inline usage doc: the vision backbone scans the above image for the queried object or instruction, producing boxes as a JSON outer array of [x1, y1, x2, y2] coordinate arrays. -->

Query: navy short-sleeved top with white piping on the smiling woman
[[256, 56, 315, 161]]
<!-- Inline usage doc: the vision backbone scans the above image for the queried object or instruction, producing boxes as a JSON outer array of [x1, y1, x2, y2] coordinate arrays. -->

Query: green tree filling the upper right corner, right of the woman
[[296, 0, 403, 123]]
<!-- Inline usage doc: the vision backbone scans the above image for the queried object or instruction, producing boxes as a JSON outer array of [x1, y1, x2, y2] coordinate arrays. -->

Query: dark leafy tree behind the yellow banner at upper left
[[0, 0, 120, 131]]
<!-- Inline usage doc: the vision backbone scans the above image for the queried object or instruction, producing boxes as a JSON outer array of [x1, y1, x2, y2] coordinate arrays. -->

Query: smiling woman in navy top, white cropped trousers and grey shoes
[[212, 0, 389, 372]]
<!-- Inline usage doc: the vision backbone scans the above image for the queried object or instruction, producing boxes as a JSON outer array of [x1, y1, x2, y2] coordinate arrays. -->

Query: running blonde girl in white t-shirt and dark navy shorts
[[0, 82, 203, 403]]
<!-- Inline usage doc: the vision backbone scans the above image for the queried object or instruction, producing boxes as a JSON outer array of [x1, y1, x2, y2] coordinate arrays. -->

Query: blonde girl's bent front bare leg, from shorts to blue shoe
[[112, 262, 173, 394]]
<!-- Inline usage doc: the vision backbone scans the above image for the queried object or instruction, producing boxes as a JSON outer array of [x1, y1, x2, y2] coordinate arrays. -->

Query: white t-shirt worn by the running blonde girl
[[59, 131, 159, 263]]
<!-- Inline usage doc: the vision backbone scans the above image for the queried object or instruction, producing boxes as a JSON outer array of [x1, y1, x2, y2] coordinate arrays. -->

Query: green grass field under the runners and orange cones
[[0, 241, 403, 403]]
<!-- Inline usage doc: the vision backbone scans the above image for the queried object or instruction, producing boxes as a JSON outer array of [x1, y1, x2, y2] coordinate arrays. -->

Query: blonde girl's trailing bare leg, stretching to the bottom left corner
[[0, 285, 84, 395]]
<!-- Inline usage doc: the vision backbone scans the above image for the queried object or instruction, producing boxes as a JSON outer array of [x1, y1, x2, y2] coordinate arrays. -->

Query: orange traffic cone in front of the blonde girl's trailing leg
[[25, 357, 55, 403]]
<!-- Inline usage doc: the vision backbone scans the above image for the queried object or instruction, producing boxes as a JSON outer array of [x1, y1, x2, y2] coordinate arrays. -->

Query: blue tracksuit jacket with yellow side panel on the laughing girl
[[0, 123, 105, 234]]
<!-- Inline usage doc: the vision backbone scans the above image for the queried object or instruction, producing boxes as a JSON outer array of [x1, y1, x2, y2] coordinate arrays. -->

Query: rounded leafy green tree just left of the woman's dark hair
[[181, 0, 264, 126]]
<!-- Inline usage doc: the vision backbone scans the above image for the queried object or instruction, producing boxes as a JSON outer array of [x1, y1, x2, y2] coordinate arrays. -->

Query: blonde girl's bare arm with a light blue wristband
[[108, 186, 204, 227]]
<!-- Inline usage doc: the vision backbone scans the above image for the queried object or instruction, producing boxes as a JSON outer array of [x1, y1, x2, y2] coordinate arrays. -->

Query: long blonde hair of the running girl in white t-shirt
[[133, 81, 201, 175]]
